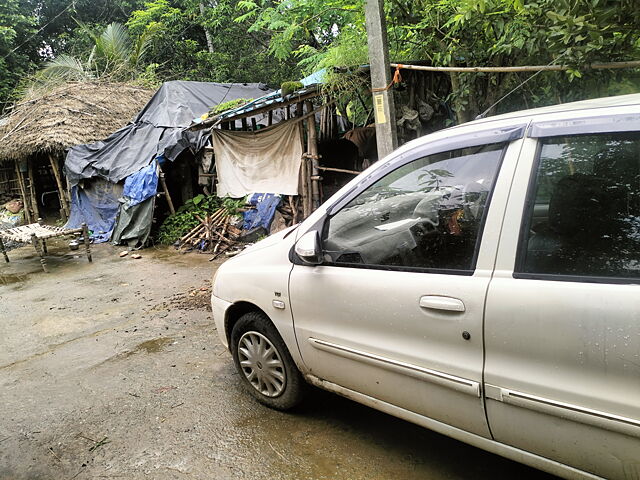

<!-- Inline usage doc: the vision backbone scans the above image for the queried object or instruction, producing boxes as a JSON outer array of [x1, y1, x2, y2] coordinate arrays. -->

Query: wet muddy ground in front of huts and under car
[[0, 242, 550, 480]]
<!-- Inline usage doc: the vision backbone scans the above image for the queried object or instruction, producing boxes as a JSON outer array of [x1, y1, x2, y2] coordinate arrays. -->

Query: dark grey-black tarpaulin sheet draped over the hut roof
[[65, 81, 269, 185]]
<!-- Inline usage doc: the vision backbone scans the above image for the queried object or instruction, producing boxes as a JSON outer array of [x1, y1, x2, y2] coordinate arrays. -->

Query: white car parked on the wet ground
[[212, 95, 640, 480]]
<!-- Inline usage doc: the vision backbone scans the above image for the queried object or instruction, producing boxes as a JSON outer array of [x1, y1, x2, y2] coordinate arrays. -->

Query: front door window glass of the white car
[[323, 144, 506, 271]]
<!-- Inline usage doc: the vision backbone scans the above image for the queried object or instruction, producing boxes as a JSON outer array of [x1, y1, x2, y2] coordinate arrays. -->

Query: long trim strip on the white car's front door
[[308, 337, 480, 397]]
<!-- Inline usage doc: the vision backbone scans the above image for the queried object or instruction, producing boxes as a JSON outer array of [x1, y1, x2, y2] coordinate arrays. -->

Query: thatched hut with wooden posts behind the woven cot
[[0, 82, 154, 222]]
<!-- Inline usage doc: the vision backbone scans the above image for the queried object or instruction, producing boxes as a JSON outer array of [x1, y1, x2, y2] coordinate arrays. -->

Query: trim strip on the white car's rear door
[[486, 384, 640, 436]]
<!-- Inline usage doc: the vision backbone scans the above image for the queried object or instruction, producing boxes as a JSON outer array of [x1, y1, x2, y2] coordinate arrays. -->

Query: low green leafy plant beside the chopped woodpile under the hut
[[157, 194, 245, 245]]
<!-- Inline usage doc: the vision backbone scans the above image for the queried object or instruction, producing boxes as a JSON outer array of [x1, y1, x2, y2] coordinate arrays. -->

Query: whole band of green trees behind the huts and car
[[0, 0, 640, 127]]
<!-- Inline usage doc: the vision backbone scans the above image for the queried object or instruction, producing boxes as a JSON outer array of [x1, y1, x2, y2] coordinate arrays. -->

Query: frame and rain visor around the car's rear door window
[[512, 129, 640, 285]]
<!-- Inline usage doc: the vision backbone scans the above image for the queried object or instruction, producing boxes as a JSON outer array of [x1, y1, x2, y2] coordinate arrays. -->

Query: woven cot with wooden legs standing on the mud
[[0, 219, 92, 272]]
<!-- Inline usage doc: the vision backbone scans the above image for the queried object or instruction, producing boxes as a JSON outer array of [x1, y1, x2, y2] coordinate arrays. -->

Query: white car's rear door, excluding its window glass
[[484, 135, 640, 478]]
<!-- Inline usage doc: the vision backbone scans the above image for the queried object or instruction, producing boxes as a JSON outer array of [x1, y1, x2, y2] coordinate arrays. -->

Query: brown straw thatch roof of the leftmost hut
[[0, 82, 153, 163]]
